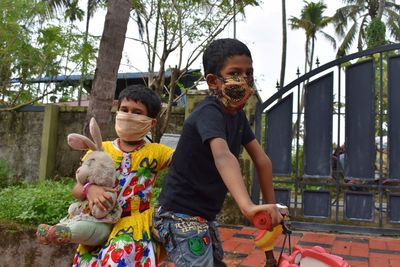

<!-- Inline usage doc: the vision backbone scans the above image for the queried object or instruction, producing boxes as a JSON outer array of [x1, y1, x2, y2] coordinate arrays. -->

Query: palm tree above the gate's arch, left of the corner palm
[[289, 1, 336, 73]]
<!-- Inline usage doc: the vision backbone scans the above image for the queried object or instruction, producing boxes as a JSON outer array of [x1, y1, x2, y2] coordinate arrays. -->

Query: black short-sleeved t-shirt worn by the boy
[[159, 96, 255, 220]]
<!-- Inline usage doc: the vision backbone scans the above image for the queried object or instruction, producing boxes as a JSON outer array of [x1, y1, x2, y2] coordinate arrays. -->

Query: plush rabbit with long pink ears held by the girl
[[36, 118, 122, 246]]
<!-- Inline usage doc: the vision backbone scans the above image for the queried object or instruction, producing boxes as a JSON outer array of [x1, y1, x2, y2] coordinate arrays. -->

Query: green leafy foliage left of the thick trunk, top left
[[0, 0, 97, 106]]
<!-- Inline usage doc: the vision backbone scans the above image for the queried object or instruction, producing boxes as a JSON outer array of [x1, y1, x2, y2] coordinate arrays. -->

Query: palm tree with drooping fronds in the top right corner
[[333, 0, 400, 57]]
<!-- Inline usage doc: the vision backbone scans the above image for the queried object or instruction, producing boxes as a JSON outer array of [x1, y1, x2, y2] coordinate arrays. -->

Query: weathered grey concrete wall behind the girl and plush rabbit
[[0, 107, 184, 183]]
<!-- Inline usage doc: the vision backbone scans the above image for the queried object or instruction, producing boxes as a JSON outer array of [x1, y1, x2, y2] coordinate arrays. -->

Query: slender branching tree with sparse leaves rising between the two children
[[132, 0, 258, 142]]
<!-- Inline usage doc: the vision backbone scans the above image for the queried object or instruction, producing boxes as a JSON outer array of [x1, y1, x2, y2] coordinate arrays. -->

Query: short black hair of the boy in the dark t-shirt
[[203, 38, 251, 76]]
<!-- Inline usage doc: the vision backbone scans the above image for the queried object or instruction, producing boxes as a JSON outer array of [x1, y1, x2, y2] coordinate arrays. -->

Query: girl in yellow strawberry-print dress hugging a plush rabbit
[[72, 85, 173, 267]]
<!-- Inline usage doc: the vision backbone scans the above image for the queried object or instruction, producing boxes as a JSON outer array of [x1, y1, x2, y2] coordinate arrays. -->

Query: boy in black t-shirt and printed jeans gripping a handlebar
[[153, 39, 282, 267]]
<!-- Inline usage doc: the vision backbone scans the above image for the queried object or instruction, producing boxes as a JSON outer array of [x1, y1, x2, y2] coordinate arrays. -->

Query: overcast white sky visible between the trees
[[84, 0, 344, 100]]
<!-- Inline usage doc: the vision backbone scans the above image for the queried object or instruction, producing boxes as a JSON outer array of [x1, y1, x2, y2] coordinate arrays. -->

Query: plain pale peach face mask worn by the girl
[[115, 111, 153, 141]]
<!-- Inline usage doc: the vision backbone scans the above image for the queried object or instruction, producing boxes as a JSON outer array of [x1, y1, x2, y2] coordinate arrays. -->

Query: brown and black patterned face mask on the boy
[[219, 76, 254, 110]]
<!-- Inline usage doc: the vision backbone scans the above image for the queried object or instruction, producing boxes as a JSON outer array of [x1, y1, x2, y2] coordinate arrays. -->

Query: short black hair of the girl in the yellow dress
[[118, 84, 161, 118]]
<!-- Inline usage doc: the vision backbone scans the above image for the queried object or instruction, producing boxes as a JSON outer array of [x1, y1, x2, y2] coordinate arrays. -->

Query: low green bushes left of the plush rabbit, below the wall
[[0, 179, 75, 224]]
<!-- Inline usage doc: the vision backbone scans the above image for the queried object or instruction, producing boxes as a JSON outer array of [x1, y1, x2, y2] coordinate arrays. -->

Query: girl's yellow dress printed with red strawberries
[[72, 140, 173, 267]]
